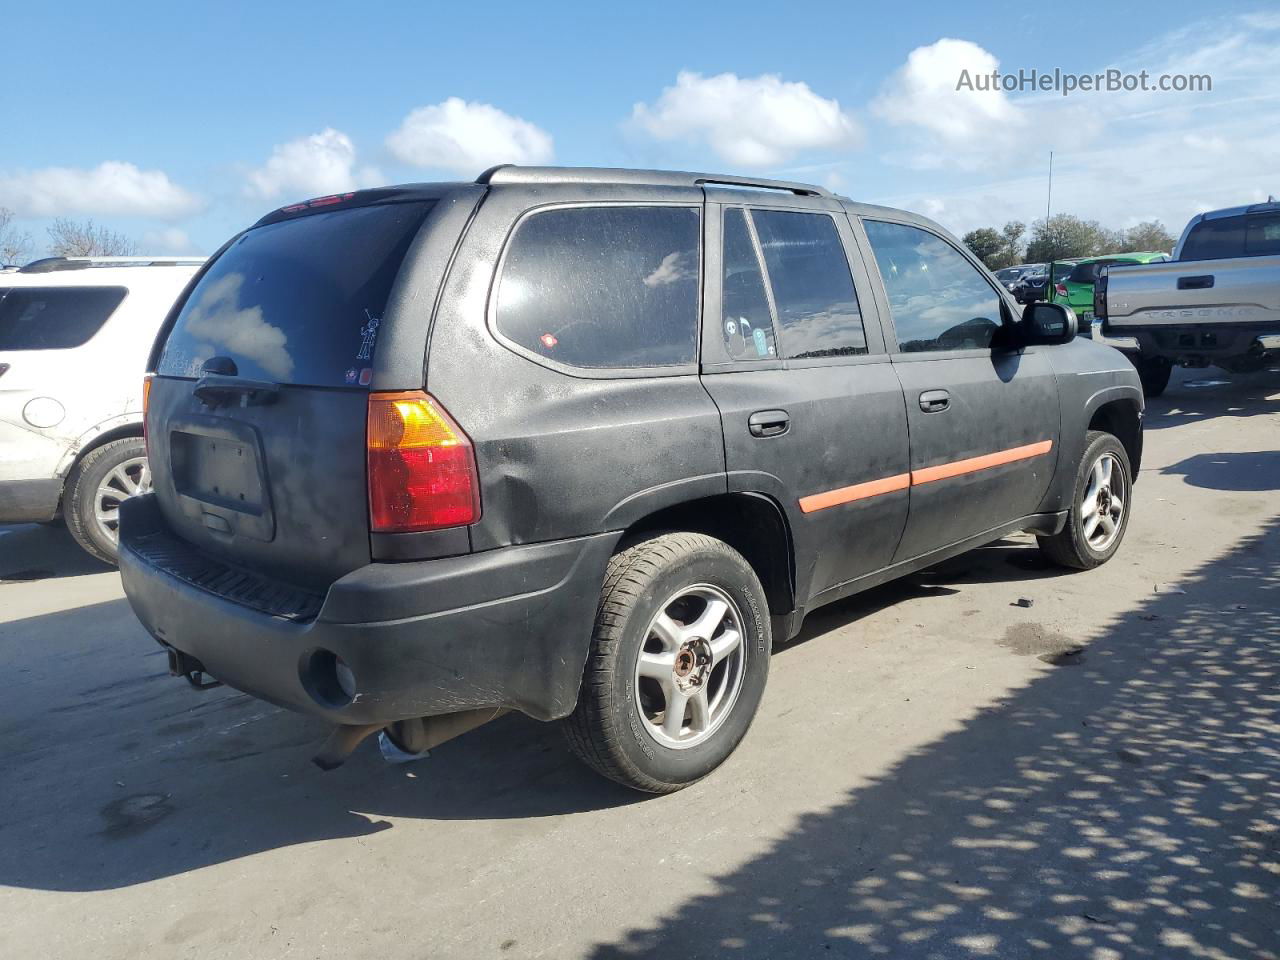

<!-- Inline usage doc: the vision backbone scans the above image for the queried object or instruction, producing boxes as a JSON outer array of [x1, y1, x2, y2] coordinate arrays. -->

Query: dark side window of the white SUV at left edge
[[0, 287, 128, 351]]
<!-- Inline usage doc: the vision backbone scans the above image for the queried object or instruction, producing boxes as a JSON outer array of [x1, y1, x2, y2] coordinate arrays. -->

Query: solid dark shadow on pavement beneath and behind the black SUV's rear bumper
[[0, 585, 644, 891]]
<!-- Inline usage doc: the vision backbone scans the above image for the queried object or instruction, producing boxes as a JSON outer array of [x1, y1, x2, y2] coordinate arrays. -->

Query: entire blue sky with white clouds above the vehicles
[[0, 0, 1280, 252]]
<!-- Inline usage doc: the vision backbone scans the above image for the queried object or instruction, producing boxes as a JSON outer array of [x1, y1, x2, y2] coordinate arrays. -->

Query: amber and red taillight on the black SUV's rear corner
[[369, 390, 480, 534]]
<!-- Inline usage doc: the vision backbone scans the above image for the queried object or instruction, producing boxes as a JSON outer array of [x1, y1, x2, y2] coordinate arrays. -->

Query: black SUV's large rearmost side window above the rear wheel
[[495, 206, 700, 367]]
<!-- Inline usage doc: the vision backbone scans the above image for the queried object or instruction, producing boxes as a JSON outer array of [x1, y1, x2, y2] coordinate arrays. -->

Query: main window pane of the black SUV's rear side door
[[751, 210, 867, 360]]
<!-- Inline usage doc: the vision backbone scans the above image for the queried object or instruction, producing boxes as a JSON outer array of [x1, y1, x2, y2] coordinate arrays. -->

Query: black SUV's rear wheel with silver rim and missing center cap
[[563, 532, 771, 794]]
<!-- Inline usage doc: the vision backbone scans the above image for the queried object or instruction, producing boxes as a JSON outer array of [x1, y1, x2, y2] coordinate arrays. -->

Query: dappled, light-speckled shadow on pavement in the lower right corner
[[593, 521, 1280, 960]]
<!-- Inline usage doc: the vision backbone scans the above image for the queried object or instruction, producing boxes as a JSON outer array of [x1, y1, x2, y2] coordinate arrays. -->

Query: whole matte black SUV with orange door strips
[[120, 166, 1143, 792]]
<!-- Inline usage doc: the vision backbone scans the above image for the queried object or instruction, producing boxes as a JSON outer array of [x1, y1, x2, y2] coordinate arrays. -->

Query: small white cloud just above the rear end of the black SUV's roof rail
[[387, 97, 554, 174]]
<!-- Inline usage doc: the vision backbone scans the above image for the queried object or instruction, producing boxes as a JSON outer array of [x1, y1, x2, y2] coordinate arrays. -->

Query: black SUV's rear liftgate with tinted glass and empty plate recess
[[147, 200, 431, 588]]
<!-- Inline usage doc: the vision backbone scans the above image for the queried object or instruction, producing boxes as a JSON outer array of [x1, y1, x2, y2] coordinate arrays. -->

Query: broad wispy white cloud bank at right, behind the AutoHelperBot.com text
[[867, 15, 1280, 236]]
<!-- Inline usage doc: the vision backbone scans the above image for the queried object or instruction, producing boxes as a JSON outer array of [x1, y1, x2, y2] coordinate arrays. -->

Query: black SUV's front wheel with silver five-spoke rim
[[1037, 430, 1133, 570]]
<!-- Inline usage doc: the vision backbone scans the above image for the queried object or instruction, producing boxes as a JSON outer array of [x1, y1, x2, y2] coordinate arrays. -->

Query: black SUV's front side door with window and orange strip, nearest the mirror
[[861, 219, 1061, 561]]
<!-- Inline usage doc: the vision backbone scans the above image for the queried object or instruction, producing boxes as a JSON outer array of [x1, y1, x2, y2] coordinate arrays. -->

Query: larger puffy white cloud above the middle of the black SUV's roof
[[631, 70, 861, 166]]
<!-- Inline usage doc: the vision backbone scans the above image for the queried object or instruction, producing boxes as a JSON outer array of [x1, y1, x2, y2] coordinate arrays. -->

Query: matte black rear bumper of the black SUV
[[120, 497, 618, 723]]
